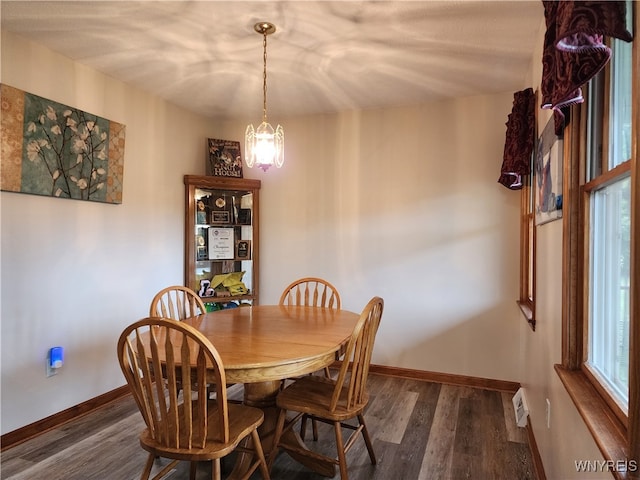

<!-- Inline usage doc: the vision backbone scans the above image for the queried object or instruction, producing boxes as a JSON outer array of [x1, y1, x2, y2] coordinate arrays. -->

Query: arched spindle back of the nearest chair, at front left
[[118, 318, 229, 448]]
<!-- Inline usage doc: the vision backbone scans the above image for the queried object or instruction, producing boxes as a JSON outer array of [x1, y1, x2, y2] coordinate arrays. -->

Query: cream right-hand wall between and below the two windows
[[520, 15, 612, 480]]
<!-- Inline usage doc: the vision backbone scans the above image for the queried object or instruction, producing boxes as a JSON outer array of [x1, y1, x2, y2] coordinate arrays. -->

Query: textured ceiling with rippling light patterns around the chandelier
[[0, 0, 543, 123]]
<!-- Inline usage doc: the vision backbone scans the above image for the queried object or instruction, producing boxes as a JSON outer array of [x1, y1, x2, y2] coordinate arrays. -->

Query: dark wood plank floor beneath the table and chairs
[[0, 374, 535, 480]]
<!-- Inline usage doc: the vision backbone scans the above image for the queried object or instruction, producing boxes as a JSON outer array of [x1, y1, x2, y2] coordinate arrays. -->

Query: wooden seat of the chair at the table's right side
[[276, 376, 369, 422]]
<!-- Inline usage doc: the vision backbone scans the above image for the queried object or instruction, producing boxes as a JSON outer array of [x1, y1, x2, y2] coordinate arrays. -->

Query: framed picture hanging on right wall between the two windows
[[533, 117, 563, 225]]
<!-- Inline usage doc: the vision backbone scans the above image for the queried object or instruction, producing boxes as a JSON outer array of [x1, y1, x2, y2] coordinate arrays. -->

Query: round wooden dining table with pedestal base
[[184, 305, 360, 477]]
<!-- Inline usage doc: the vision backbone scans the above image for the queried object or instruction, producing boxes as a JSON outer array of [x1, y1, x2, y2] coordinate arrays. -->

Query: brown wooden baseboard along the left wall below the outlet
[[0, 385, 131, 452]]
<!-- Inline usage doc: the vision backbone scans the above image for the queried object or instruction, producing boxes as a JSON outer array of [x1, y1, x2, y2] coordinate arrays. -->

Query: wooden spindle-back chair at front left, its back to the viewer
[[118, 318, 269, 480]]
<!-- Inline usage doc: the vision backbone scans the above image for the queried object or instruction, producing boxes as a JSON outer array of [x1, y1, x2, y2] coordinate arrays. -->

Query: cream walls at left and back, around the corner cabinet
[[0, 29, 523, 433]]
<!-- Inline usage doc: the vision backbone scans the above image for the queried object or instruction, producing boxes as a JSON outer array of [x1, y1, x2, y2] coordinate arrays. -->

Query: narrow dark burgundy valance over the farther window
[[498, 88, 536, 190]]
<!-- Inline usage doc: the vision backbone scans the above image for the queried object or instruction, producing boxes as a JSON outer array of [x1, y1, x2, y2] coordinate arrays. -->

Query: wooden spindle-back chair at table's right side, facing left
[[269, 297, 384, 480]]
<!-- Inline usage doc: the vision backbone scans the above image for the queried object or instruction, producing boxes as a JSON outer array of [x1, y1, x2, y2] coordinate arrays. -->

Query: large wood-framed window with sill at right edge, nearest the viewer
[[557, 1, 640, 479]]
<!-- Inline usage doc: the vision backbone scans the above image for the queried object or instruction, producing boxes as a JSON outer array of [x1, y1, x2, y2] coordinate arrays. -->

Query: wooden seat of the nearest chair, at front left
[[140, 402, 264, 461]]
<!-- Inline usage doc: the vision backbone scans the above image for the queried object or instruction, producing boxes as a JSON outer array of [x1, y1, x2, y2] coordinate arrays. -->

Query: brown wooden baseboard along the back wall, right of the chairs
[[369, 364, 520, 393]]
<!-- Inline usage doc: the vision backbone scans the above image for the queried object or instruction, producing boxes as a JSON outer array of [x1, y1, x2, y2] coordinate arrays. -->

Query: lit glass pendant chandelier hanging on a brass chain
[[244, 22, 284, 172]]
